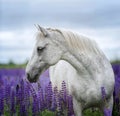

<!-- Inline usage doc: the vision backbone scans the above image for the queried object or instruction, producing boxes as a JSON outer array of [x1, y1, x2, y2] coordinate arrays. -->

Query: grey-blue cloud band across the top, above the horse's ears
[[0, 0, 120, 29]]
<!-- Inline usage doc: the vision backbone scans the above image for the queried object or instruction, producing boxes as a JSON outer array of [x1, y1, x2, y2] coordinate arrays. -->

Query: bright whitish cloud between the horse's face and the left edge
[[0, 29, 35, 63]]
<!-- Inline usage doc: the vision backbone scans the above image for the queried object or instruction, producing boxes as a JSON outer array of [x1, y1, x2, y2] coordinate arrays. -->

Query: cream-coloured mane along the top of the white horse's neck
[[48, 28, 102, 54]]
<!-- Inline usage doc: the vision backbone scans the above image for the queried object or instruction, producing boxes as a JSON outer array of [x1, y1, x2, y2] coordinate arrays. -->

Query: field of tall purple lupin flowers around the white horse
[[0, 65, 120, 116]]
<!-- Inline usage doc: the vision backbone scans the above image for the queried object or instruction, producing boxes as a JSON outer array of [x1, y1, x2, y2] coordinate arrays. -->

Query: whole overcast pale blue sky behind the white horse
[[0, 0, 120, 63]]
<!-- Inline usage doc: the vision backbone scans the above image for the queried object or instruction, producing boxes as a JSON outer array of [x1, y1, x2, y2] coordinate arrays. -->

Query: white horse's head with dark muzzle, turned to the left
[[26, 25, 63, 82]]
